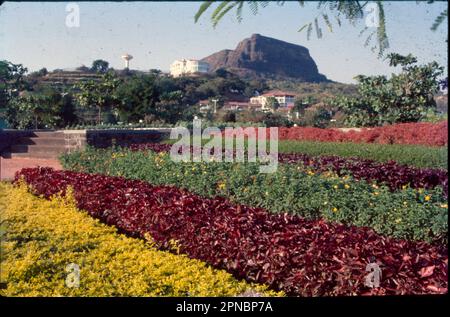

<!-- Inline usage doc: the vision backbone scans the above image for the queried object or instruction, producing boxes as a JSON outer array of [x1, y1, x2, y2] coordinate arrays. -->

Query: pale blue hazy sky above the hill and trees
[[0, 1, 448, 83]]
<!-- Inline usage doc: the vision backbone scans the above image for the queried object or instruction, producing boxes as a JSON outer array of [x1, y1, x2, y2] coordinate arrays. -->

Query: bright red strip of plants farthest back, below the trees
[[224, 121, 448, 146]]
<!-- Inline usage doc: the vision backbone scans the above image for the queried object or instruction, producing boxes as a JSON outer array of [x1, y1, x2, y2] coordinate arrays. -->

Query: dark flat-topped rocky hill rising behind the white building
[[202, 34, 329, 82]]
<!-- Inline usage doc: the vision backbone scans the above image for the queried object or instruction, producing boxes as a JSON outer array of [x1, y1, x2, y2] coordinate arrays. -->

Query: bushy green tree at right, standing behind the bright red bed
[[332, 54, 444, 127]]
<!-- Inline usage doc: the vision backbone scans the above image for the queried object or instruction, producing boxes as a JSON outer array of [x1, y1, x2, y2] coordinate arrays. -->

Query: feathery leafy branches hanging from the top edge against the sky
[[194, 0, 448, 56]]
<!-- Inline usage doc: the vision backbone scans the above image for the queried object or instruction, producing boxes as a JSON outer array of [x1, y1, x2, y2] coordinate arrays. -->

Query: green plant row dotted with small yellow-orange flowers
[[59, 149, 448, 240]]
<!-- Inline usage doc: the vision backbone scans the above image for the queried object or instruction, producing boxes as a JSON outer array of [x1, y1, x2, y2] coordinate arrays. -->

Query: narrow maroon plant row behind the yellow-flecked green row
[[130, 143, 448, 197]]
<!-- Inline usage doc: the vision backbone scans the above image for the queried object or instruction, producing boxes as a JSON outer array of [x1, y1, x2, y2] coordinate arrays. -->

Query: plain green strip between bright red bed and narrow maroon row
[[278, 141, 448, 169]]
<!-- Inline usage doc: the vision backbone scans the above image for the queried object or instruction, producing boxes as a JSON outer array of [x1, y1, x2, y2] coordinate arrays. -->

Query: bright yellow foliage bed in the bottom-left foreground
[[0, 183, 280, 296]]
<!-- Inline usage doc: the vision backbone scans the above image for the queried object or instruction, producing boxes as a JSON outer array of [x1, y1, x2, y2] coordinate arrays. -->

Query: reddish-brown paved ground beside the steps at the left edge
[[0, 157, 62, 180]]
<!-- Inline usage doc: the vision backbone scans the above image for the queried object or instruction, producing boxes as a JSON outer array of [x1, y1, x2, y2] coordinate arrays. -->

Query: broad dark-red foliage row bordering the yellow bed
[[17, 168, 448, 296]]
